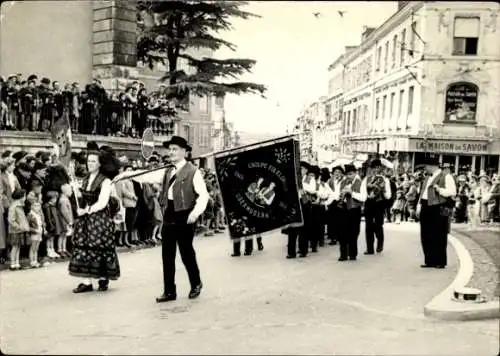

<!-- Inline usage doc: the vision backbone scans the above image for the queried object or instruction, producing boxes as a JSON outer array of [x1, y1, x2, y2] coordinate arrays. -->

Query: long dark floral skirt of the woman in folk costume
[[69, 209, 120, 280]]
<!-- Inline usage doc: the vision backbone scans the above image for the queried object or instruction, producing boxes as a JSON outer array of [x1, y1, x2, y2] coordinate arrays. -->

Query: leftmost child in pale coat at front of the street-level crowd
[[7, 189, 30, 270]]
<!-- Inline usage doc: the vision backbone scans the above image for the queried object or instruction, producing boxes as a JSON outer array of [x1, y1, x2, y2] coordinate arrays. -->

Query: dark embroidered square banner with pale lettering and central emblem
[[214, 138, 303, 240]]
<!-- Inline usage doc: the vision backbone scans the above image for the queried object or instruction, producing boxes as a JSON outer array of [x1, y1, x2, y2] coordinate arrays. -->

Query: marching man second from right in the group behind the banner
[[339, 164, 367, 261]]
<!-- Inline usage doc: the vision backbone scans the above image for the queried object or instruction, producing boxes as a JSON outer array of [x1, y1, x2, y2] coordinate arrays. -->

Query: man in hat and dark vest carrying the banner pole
[[156, 136, 209, 303]]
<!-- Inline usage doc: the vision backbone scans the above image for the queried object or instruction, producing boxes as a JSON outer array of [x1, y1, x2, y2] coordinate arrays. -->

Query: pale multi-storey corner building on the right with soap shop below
[[331, 1, 500, 173]]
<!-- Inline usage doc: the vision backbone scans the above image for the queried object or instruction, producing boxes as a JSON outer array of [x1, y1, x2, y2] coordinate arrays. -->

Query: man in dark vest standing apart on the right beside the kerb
[[417, 155, 457, 268]]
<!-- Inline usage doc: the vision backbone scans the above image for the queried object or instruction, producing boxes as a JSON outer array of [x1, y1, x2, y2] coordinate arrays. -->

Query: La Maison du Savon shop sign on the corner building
[[412, 139, 488, 154]]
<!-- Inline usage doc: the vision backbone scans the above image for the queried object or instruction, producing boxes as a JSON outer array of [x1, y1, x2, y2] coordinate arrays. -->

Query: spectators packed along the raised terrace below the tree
[[0, 74, 174, 137]]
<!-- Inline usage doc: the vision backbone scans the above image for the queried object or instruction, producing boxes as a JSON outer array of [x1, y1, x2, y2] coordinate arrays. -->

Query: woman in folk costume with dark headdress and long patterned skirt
[[69, 146, 120, 293]]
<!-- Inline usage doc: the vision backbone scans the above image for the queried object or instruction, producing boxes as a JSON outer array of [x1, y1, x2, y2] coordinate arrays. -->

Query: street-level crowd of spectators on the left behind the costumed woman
[[0, 142, 225, 270]]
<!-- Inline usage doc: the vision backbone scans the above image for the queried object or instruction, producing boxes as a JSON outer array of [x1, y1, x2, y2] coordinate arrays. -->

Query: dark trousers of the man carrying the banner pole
[[161, 200, 201, 294]]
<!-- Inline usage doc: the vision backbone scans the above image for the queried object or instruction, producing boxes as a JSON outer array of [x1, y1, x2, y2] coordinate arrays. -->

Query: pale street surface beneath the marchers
[[0, 224, 499, 355]]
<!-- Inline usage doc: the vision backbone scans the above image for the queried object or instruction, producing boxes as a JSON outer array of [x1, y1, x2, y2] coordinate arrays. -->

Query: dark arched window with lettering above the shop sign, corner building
[[444, 82, 479, 123]]
